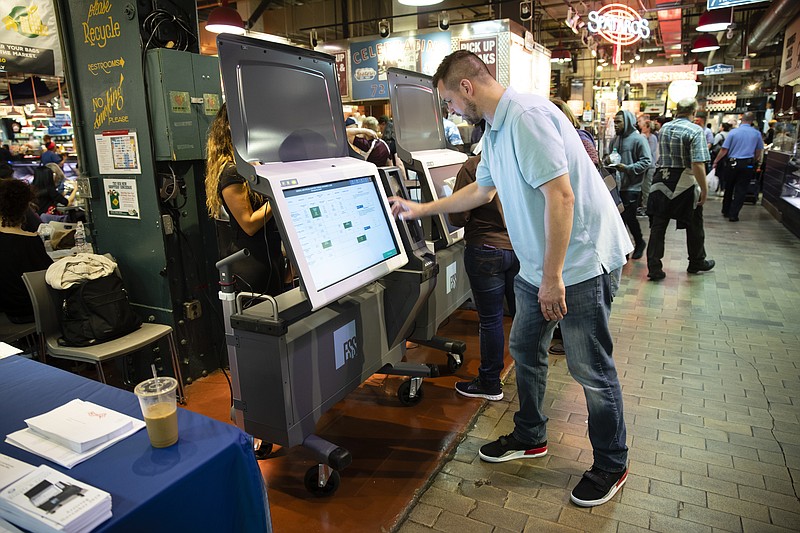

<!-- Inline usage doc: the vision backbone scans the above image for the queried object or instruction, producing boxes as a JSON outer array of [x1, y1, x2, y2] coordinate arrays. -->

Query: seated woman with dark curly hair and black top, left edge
[[0, 179, 53, 324]]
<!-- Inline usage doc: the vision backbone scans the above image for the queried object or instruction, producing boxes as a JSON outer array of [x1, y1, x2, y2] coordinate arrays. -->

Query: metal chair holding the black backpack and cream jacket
[[22, 270, 185, 403]]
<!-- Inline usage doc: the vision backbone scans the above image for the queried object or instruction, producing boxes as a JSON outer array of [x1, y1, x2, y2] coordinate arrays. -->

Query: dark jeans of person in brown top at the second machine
[[464, 245, 519, 386]]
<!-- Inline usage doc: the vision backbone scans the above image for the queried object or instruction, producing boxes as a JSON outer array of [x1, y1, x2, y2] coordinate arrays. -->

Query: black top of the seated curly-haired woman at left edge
[[0, 233, 53, 324]]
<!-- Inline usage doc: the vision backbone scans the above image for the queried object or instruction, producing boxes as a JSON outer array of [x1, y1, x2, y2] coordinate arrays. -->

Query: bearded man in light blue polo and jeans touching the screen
[[392, 50, 632, 507]]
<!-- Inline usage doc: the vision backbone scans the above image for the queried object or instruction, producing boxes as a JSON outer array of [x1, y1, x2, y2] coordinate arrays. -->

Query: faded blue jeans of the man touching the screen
[[509, 274, 628, 472]]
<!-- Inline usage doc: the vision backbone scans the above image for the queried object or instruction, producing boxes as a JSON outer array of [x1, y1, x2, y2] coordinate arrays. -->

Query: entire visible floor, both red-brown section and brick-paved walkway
[[184, 198, 800, 533]]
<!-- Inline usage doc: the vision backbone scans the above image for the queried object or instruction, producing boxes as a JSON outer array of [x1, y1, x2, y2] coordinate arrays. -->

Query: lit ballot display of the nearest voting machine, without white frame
[[284, 177, 400, 291]]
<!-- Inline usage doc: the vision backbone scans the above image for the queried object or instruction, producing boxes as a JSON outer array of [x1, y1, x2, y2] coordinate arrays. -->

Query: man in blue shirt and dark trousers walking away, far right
[[713, 111, 764, 222]]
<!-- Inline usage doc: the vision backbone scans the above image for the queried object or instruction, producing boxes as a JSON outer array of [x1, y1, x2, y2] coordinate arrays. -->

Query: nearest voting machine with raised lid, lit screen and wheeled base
[[217, 34, 435, 493]]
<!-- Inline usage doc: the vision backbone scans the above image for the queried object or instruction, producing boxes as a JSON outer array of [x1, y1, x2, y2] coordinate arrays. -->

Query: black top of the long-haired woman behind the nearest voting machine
[[217, 165, 286, 295]]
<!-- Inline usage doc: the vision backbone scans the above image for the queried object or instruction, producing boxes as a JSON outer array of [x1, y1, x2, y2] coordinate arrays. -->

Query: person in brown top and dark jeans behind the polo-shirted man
[[449, 155, 519, 401]]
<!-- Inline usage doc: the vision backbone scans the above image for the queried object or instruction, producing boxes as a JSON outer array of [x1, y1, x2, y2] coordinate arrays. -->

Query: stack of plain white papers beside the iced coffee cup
[[6, 399, 145, 468]]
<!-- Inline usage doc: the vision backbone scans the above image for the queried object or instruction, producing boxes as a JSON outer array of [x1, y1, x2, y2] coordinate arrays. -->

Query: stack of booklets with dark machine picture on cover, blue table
[[0, 458, 111, 533]]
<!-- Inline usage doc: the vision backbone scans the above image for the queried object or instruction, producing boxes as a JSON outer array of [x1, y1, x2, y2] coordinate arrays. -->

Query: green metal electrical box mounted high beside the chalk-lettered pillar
[[146, 48, 222, 161]]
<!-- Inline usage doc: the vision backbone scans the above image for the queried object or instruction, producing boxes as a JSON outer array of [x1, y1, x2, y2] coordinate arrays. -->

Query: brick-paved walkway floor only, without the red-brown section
[[398, 198, 800, 533]]
